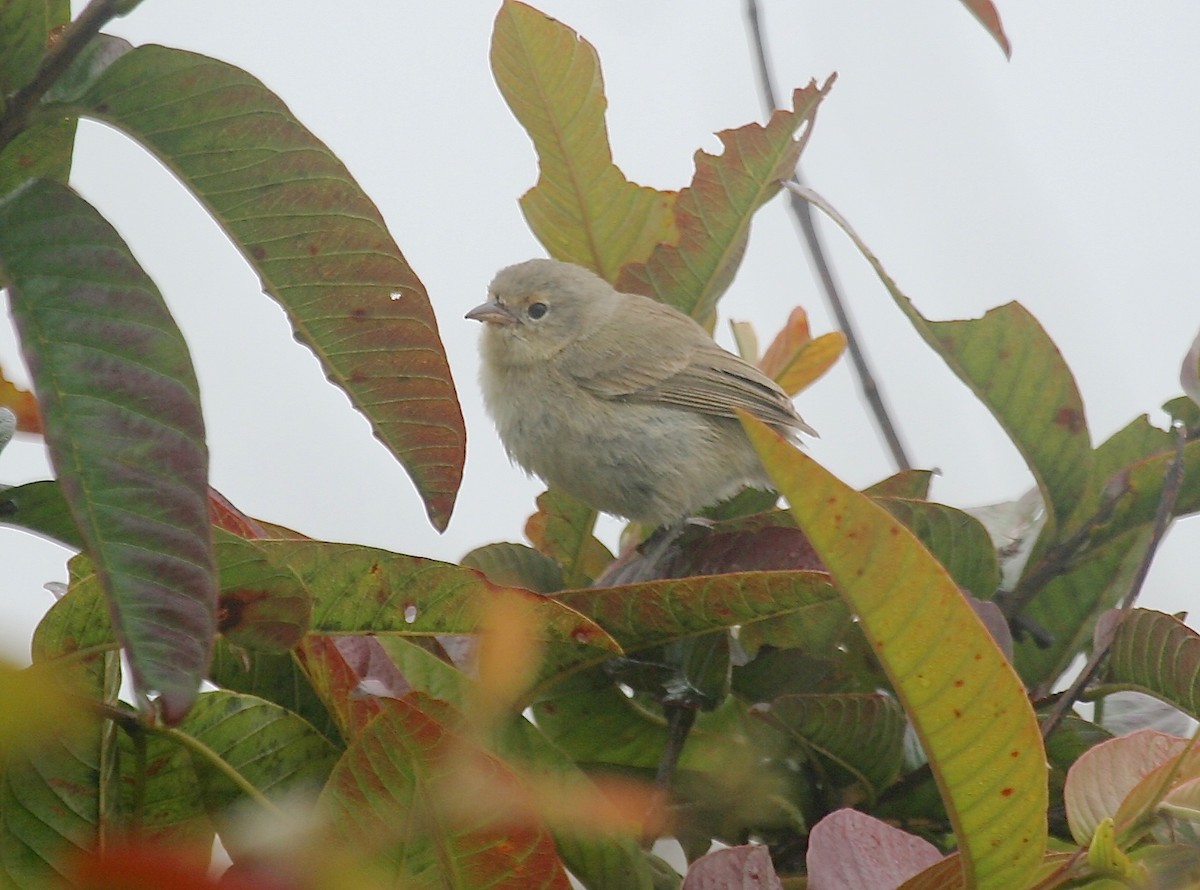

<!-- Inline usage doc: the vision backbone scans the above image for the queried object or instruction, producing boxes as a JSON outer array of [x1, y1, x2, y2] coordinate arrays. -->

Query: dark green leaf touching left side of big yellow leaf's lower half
[[750, 693, 905, 796]]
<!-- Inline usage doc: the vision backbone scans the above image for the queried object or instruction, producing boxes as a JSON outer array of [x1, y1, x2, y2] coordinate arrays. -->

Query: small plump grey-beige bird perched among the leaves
[[467, 259, 816, 524]]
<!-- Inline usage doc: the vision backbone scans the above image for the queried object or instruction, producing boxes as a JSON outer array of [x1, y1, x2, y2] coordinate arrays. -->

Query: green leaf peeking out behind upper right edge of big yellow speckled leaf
[[875, 498, 1000, 600]]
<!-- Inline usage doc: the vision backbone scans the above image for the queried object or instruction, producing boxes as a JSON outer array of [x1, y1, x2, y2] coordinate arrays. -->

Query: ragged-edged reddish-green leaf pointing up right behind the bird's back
[[617, 78, 833, 330]]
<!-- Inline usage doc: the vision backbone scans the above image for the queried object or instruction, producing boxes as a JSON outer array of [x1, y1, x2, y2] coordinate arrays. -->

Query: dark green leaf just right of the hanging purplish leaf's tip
[[175, 690, 341, 860]]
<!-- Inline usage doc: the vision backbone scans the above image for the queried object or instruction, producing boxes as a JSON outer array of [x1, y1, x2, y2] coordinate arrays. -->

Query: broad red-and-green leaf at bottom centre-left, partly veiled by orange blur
[[320, 696, 570, 890]]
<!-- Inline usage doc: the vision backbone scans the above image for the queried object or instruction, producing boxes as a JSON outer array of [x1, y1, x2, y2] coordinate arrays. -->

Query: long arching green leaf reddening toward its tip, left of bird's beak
[[64, 46, 466, 529]]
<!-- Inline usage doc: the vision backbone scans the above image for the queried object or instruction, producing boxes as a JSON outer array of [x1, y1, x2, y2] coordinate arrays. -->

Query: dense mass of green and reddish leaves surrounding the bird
[[0, 0, 1200, 890]]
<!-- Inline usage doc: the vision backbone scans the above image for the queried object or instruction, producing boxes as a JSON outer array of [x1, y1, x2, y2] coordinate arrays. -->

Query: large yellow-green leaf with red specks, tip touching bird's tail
[[743, 417, 1048, 890]]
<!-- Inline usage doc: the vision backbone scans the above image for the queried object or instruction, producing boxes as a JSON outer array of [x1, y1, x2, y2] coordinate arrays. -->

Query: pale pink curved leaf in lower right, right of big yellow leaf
[[1062, 729, 1188, 847]]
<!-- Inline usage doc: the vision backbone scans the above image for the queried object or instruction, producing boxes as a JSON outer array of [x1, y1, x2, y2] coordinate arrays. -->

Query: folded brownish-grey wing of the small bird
[[569, 300, 812, 433]]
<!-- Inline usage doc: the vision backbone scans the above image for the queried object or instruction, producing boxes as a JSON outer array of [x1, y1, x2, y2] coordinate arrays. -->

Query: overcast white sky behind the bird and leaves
[[0, 0, 1200, 659]]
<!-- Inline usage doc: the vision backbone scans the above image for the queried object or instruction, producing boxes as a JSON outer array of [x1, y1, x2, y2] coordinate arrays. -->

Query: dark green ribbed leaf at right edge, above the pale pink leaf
[[1108, 609, 1200, 718]]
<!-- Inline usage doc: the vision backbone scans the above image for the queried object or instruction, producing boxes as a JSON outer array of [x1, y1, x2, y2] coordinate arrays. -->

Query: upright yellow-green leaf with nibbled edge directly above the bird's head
[[491, 0, 677, 282]]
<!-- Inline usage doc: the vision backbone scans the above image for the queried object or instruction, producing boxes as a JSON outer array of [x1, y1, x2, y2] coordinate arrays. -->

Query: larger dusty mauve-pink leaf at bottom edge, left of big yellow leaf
[[808, 810, 945, 890]]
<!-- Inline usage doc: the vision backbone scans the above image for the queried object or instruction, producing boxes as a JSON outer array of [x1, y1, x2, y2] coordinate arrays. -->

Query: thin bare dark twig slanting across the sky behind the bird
[[746, 0, 912, 470]]
